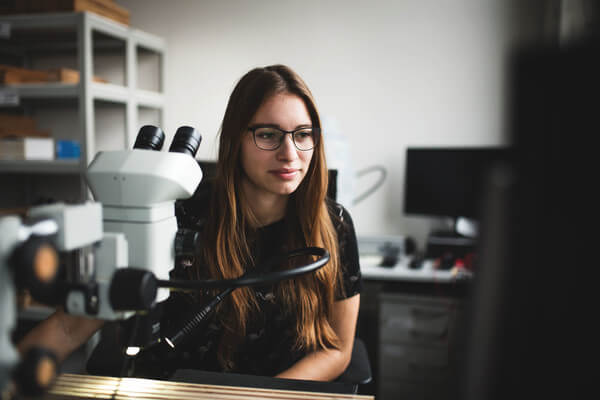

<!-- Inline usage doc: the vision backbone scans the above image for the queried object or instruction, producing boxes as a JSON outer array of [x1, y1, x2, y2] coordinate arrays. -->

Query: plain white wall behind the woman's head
[[118, 0, 509, 247]]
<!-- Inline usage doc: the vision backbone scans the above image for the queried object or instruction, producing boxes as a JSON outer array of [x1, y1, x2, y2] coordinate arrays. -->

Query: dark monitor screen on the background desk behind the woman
[[404, 147, 509, 219]]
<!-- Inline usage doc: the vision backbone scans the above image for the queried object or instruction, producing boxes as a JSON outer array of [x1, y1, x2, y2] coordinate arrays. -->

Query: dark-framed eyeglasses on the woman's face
[[248, 125, 321, 151]]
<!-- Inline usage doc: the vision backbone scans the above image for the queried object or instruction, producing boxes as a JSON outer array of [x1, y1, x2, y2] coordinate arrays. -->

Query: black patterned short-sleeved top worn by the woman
[[136, 191, 362, 377]]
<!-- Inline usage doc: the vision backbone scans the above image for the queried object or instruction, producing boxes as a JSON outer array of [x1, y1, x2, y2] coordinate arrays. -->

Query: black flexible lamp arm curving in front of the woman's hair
[[157, 247, 329, 290]]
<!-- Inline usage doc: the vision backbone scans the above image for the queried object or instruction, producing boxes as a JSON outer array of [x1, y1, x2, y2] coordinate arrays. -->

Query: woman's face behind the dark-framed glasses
[[241, 93, 314, 202]]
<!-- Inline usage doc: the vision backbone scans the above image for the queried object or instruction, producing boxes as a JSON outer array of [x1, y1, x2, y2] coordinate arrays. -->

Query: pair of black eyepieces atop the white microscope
[[133, 125, 202, 157]]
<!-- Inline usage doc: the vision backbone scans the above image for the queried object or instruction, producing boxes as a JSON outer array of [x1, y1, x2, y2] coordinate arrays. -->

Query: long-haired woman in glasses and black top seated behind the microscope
[[18, 65, 360, 380]]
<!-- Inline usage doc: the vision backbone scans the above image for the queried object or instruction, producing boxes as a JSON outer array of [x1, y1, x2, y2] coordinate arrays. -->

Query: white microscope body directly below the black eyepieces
[[67, 149, 202, 319]]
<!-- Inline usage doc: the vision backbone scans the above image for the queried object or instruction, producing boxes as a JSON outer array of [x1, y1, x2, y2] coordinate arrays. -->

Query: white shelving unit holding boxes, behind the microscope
[[0, 12, 166, 208]]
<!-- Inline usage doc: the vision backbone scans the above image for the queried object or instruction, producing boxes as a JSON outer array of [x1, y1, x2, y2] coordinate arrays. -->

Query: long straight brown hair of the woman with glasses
[[196, 65, 342, 369]]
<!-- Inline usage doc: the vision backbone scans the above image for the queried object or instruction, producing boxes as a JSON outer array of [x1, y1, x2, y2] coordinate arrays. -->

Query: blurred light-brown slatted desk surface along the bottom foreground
[[43, 374, 374, 400]]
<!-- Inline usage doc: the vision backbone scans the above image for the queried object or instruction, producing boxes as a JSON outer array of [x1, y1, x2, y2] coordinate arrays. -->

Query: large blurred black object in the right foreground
[[459, 41, 600, 400]]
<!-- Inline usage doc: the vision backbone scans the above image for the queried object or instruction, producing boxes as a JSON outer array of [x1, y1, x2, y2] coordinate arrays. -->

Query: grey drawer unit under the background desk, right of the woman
[[378, 293, 458, 400]]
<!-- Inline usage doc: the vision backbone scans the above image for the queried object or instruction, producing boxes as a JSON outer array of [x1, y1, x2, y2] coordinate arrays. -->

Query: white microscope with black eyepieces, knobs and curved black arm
[[0, 125, 329, 394]]
